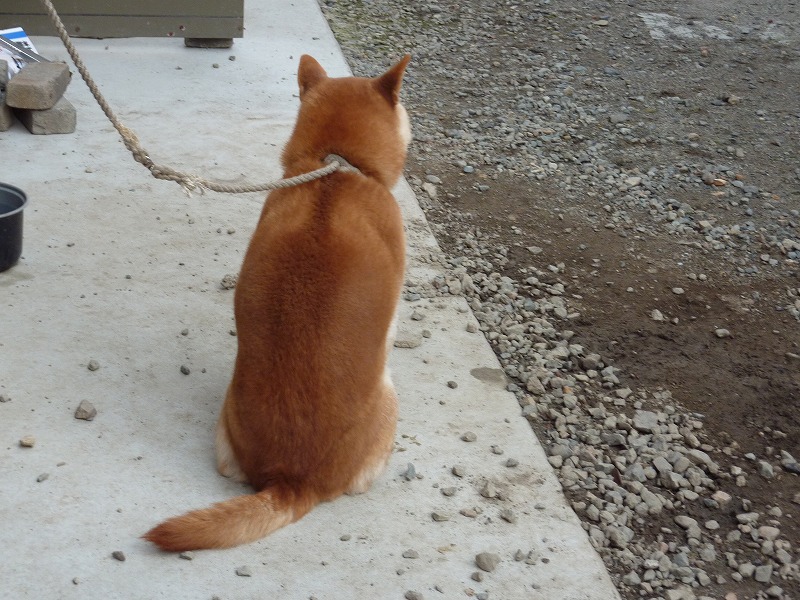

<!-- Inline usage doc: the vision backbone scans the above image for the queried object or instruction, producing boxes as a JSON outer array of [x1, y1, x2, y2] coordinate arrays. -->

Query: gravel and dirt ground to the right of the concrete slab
[[321, 0, 800, 600]]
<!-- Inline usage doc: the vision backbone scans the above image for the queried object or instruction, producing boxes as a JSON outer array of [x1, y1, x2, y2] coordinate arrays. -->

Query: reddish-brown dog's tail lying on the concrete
[[142, 486, 318, 552]]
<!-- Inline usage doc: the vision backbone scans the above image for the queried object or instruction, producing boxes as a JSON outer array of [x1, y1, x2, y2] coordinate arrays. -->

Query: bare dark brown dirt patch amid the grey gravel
[[430, 172, 800, 460]]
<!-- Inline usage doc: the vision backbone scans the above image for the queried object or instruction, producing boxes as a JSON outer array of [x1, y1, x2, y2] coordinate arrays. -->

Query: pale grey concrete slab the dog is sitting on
[[0, 0, 618, 600]]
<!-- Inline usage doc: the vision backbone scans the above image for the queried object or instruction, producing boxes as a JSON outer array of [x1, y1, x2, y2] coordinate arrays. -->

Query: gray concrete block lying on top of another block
[[6, 62, 72, 110]]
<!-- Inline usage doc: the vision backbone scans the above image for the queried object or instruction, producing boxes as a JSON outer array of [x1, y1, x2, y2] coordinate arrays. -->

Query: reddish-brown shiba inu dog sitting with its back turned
[[144, 55, 411, 551]]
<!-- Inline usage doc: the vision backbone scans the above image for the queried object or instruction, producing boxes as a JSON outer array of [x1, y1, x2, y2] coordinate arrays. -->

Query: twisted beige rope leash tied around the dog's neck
[[42, 0, 346, 195]]
